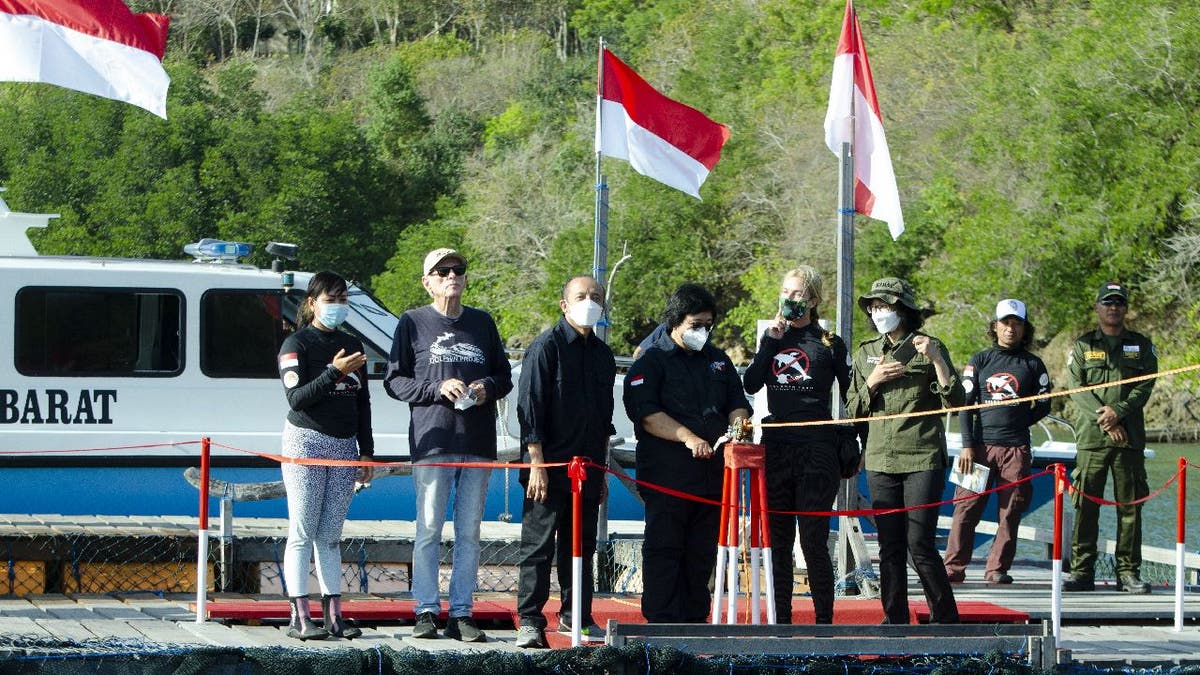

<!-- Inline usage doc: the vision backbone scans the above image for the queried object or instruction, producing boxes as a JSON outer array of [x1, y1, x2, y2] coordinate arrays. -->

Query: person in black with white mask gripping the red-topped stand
[[624, 283, 750, 623]]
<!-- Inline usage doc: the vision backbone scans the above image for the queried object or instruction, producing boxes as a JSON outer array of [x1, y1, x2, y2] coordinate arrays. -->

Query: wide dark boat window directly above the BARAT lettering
[[16, 287, 184, 377]]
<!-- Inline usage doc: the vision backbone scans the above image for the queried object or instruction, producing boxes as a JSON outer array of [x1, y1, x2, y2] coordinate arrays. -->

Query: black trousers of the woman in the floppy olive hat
[[866, 470, 959, 623]]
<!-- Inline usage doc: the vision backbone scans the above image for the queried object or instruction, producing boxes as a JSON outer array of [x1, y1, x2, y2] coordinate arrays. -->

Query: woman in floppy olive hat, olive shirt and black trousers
[[848, 276, 962, 623]]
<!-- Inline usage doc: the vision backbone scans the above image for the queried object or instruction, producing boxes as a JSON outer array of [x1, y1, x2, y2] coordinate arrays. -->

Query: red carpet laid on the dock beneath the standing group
[[201, 596, 1030, 624]]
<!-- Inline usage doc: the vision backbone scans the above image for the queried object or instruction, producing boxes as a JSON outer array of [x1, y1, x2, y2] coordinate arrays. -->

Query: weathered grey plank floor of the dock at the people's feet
[[0, 581, 1200, 668]]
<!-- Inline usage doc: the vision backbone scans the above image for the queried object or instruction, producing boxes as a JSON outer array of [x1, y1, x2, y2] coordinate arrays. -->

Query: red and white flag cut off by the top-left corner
[[0, 0, 170, 119]]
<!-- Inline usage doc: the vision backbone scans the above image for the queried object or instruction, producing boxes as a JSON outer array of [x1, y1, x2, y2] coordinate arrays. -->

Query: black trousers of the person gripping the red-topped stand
[[642, 490, 721, 623]]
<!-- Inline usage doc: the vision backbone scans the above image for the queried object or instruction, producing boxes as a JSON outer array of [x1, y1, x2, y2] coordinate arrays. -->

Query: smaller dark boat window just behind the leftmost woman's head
[[200, 289, 295, 380]]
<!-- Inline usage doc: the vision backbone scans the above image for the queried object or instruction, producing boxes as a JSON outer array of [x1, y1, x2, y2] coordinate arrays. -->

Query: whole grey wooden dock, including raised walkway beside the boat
[[0, 515, 1200, 668]]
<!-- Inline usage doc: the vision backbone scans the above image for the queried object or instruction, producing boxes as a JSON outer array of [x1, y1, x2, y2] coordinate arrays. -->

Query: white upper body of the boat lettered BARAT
[[0, 190, 408, 466]]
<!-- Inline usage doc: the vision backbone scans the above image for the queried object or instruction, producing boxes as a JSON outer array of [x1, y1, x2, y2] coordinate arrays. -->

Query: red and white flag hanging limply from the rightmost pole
[[826, 0, 904, 239]]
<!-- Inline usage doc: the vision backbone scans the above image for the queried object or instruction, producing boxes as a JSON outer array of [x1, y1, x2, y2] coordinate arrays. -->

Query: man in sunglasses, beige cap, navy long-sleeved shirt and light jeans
[[384, 249, 512, 643]]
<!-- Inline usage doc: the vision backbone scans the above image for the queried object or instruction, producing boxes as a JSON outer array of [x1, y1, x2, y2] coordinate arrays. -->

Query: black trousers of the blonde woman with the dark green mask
[[766, 434, 841, 623]]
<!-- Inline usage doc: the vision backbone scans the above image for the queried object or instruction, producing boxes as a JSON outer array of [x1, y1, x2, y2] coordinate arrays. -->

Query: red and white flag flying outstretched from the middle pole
[[596, 49, 730, 199]]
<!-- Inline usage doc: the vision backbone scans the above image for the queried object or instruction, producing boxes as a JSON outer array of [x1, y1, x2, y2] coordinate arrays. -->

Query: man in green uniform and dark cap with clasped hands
[[1062, 282, 1158, 593]]
